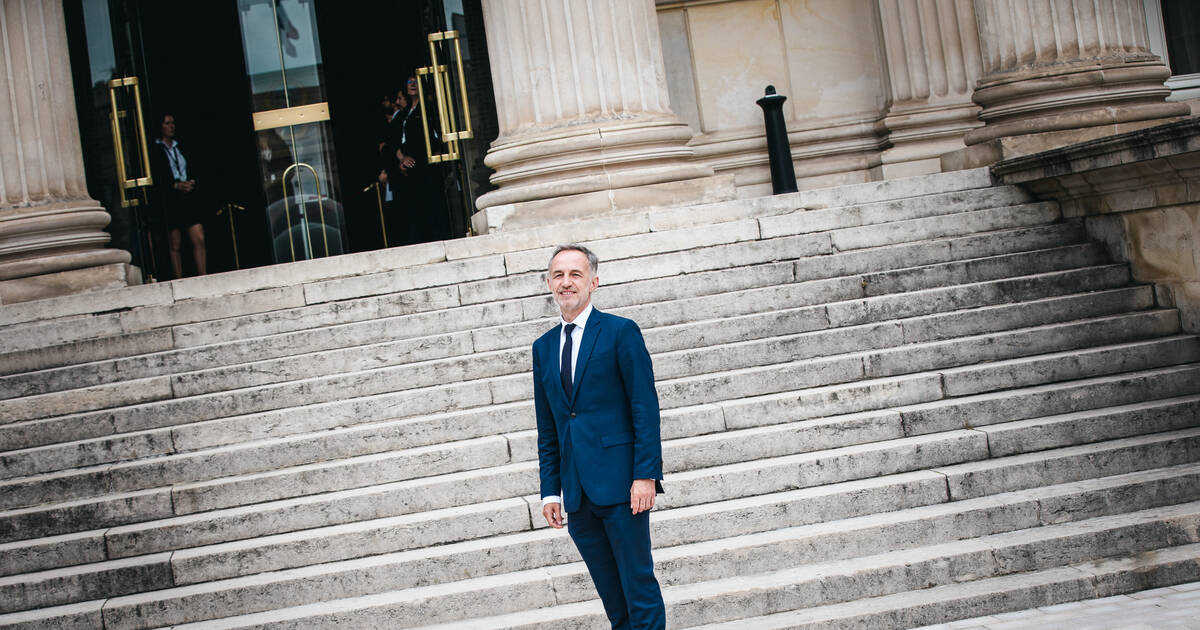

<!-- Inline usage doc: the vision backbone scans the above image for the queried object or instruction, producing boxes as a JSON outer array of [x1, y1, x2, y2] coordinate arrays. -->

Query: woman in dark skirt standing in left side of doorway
[[150, 114, 208, 278]]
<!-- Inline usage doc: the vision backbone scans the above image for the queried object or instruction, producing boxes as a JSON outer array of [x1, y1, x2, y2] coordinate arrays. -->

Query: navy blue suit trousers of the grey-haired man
[[566, 494, 666, 630]]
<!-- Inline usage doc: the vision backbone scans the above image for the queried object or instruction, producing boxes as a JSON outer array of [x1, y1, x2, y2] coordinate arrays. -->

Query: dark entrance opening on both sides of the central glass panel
[[64, 0, 496, 280]]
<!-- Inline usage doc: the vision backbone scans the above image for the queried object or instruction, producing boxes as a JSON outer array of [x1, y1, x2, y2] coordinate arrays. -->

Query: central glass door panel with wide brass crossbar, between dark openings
[[238, 0, 348, 263]]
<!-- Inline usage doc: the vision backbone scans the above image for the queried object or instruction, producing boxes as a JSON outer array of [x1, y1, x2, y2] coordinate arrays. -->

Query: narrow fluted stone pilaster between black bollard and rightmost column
[[878, 0, 983, 179]]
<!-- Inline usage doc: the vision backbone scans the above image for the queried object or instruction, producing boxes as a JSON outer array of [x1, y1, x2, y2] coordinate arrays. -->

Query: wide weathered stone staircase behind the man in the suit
[[0, 169, 1200, 630]]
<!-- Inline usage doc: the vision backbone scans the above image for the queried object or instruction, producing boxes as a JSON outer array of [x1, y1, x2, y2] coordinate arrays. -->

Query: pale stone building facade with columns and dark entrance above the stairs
[[0, 0, 1200, 304]]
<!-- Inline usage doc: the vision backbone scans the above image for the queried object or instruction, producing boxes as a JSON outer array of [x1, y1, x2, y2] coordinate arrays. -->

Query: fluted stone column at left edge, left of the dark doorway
[[0, 0, 130, 302]]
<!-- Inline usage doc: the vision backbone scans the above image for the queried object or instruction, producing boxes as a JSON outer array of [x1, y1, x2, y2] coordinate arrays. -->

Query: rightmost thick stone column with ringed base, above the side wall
[[965, 0, 1190, 150]]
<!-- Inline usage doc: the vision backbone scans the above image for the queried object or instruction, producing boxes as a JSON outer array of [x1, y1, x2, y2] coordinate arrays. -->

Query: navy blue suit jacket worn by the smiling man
[[533, 308, 662, 512]]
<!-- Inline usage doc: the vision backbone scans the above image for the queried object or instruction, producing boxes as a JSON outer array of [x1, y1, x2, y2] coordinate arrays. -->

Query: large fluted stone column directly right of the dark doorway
[[475, 0, 733, 232]]
